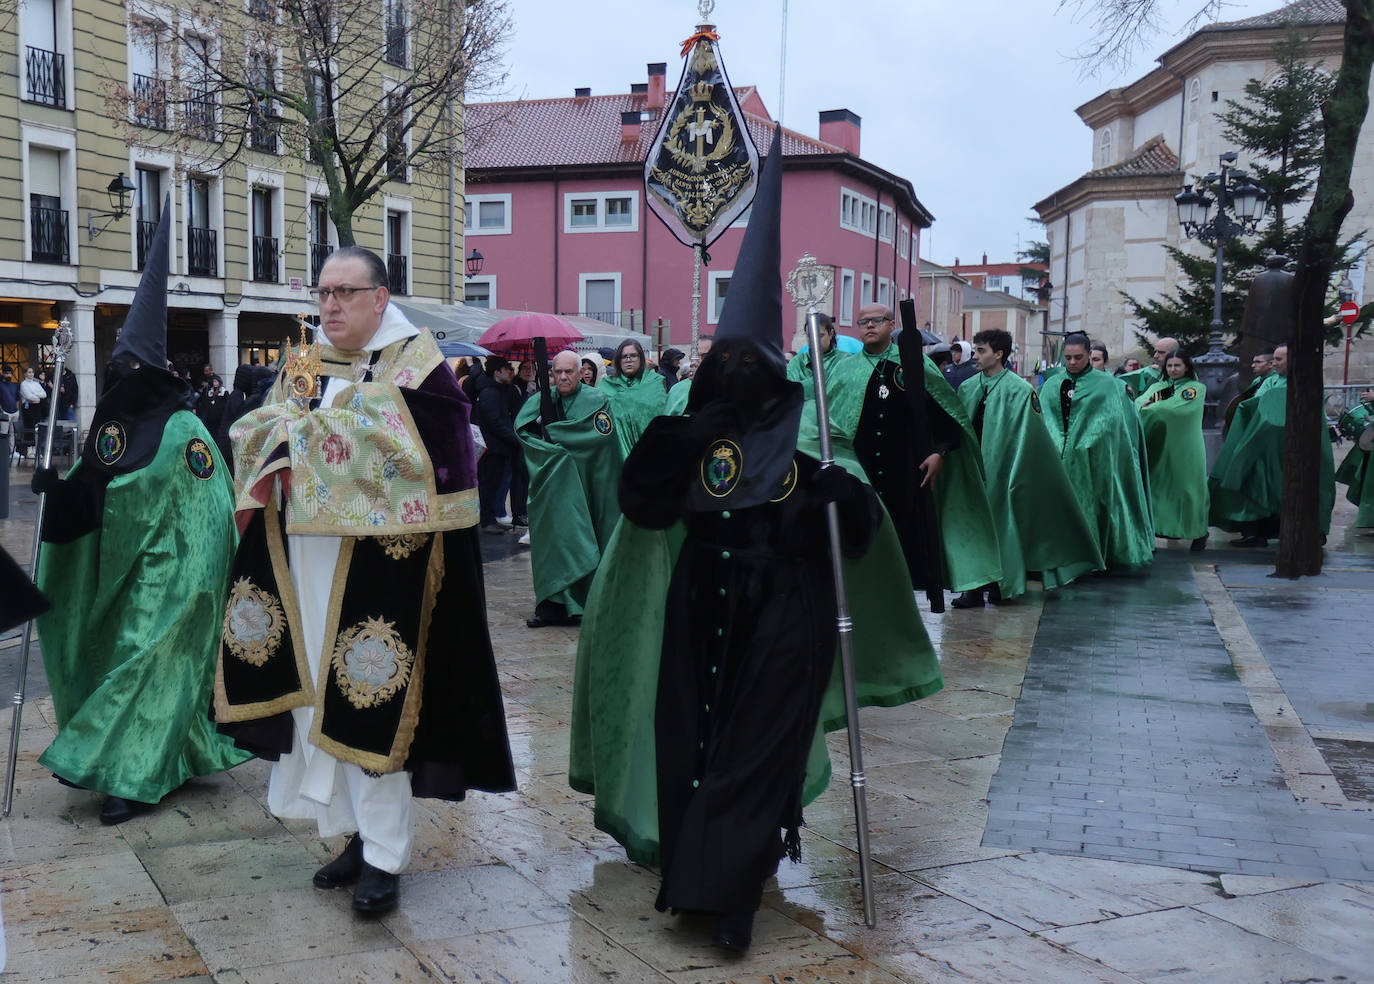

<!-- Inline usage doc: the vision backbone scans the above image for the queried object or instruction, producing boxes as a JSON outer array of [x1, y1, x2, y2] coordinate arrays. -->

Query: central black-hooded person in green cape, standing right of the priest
[[569, 127, 941, 950]]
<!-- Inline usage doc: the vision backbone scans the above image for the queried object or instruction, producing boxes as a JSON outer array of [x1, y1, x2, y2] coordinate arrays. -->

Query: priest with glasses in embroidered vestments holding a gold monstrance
[[214, 246, 515, 913]]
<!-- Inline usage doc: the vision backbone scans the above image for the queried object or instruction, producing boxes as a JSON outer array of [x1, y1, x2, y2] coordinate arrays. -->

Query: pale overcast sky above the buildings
[[506, 0, 1283, 264]]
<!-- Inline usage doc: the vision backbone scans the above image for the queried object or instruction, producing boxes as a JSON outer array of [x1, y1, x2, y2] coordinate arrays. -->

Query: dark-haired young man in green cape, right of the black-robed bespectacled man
[[954, 328, 1103, 607]]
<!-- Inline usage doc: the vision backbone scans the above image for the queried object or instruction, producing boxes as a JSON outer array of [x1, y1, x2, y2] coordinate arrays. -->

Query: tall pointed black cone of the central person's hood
[[716, 125, 786, 371]]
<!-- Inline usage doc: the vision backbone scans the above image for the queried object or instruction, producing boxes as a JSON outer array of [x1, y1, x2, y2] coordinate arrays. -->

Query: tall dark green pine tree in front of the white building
[[1123, 29, 1363, 355]]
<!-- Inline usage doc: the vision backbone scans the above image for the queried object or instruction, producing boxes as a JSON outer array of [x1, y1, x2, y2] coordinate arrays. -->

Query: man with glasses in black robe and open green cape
[[826, 304, 1002, 612]]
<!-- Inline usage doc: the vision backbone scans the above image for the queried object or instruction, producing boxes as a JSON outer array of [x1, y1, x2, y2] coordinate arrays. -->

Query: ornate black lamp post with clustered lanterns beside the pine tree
[[1173, 150, 1270, 427]]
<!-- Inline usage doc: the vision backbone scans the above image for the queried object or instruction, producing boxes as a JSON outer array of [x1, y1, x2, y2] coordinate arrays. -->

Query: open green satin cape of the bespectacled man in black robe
[[802, 345, 1003, 591]]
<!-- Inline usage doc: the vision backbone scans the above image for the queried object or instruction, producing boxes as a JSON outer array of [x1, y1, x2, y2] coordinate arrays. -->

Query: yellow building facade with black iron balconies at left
[[0, 0, 463, 432]]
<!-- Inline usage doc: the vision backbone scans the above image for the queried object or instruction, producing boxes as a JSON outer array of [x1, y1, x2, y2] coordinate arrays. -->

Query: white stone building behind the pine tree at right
[[1035, 0, 1374, 382]]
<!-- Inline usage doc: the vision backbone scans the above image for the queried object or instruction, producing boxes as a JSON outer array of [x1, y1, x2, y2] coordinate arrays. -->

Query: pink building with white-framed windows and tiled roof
[[464, 63, 932, 349]]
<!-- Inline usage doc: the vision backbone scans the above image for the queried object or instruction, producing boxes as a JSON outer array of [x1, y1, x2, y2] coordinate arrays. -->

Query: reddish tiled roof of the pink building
[[466, 87, 845, 170]]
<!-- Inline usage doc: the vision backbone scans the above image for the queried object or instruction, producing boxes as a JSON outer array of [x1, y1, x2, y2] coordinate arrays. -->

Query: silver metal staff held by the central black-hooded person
[[787, 254, 878, 928]]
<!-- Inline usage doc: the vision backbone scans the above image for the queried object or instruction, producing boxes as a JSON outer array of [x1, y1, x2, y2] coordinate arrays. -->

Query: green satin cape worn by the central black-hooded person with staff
[[567, 442, 944, 864]]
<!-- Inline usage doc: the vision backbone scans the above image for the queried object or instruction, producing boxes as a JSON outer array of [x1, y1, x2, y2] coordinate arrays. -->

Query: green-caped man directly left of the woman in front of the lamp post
[[1040, 334, 1154, 569]]
